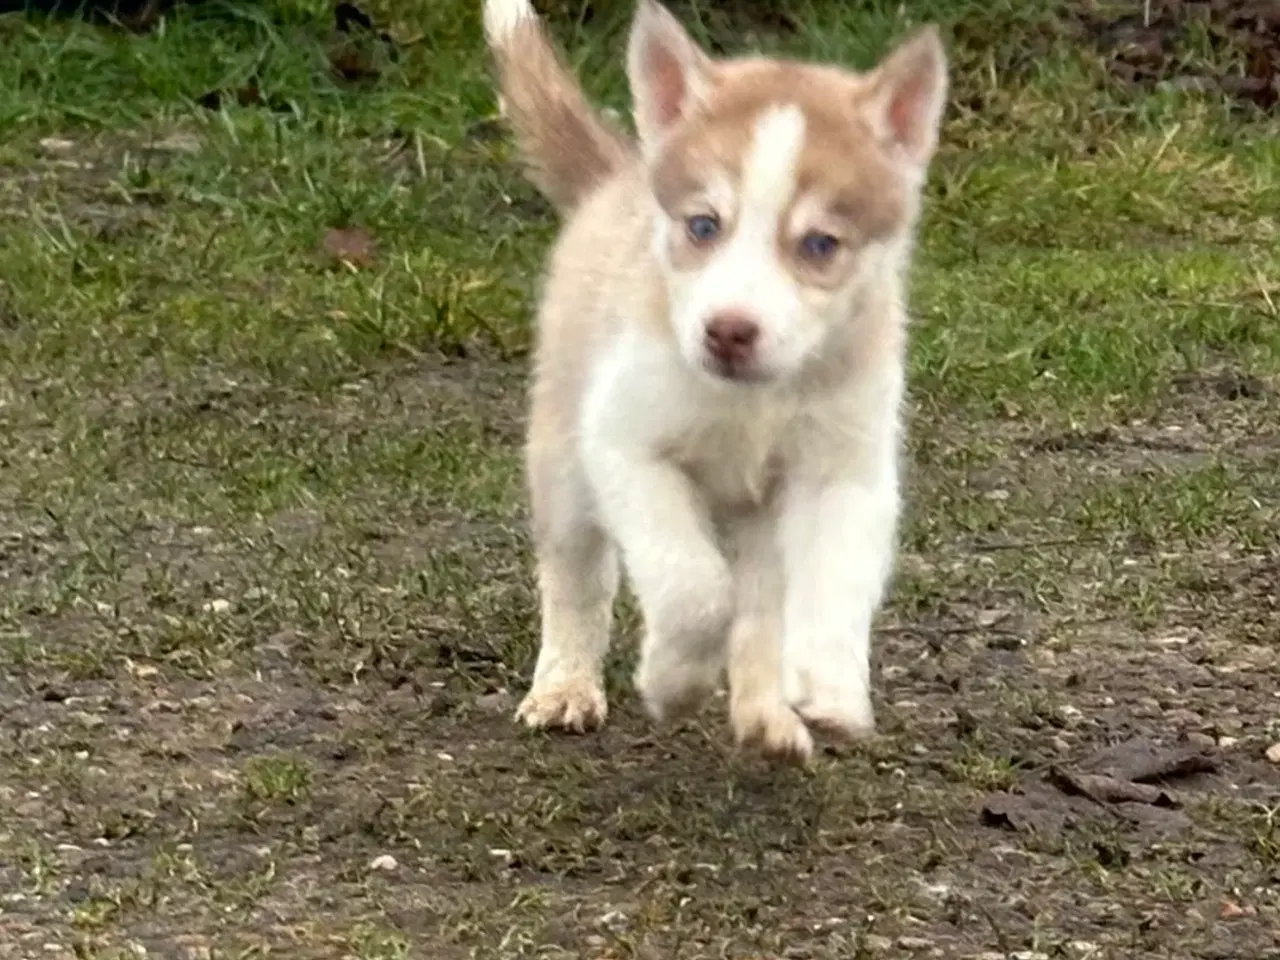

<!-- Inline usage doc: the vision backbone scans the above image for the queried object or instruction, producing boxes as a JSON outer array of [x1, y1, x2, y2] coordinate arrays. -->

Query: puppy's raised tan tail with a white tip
[[484, 0, 632, 214]]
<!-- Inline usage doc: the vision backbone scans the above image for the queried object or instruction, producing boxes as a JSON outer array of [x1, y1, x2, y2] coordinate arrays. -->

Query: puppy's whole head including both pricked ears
[[630, 0, 941, 383]]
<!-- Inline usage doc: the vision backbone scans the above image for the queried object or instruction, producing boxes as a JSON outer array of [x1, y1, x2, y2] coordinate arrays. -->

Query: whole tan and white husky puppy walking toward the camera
[[484, 0, 947, 763]]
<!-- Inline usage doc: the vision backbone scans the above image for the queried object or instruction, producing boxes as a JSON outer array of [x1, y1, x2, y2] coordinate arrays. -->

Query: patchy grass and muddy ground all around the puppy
[[0, 0, 1280, 960]]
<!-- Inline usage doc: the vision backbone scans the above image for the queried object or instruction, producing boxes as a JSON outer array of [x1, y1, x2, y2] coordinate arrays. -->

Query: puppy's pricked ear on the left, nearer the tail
[[627, 0, 712, 154]]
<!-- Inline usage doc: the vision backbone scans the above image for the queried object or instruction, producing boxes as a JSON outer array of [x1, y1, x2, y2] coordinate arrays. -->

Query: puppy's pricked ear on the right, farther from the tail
[[870, 24, 947, 177]]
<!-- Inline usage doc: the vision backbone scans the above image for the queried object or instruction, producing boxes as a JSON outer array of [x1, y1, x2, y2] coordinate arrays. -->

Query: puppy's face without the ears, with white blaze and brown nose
[[652, 76, 908, 381]]
